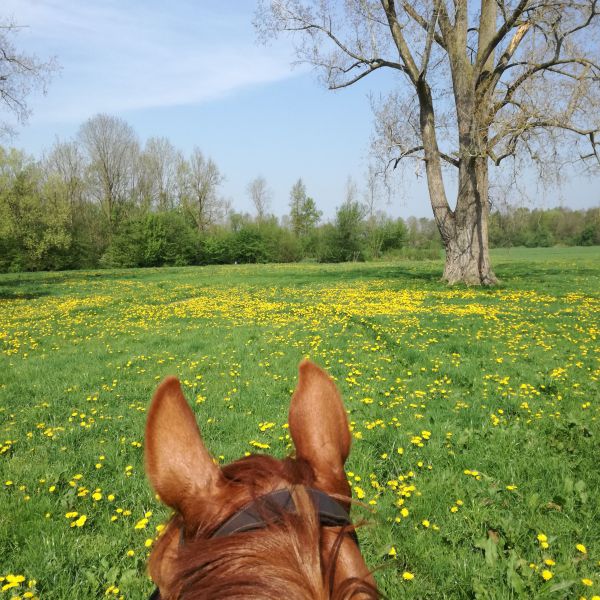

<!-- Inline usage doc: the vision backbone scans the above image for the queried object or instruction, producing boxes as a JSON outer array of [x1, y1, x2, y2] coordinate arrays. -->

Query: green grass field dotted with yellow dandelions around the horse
[[0, 248, 600, 600]]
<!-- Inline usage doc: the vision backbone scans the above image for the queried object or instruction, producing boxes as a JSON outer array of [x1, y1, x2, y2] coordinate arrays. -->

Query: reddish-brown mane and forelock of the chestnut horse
[[150, 456, 379, 600]]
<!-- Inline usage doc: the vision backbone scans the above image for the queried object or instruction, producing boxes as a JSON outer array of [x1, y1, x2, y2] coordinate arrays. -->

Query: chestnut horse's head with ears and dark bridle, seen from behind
[[145, 361, 378, 600]]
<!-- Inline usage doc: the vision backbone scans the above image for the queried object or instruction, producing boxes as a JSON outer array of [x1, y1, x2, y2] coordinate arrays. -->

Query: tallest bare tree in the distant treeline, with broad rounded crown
[[79, 114, 139, 233]]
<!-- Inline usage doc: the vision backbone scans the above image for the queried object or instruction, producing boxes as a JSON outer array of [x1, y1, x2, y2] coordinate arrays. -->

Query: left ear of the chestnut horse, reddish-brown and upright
[[144, 377, 223, 522]]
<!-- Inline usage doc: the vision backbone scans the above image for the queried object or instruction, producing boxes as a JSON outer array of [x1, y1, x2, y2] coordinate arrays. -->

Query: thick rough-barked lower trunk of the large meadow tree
[[443, 156, 498, 285]]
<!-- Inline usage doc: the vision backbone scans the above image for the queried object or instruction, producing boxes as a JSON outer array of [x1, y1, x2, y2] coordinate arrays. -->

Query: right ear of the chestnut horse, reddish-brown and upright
[[288, 360, 351, 495]]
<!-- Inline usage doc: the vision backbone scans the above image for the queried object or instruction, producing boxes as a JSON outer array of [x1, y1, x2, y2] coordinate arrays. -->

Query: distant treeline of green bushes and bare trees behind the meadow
[[0, 115, 600, 272]]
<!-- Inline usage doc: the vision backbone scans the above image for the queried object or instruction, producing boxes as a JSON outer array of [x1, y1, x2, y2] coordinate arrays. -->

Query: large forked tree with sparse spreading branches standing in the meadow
[[257, 0, 600, 284]]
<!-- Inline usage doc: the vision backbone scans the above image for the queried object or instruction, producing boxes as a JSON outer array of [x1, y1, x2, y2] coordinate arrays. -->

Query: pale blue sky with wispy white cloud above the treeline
[[0, 0, 600, 218]]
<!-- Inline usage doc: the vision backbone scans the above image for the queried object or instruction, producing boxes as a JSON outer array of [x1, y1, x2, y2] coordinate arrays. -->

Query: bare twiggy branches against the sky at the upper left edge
[[0, 19, 58, 138]]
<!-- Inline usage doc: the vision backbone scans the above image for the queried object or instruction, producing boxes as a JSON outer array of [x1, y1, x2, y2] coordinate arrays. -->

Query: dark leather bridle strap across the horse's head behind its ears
[[150, 488, 359, 600]]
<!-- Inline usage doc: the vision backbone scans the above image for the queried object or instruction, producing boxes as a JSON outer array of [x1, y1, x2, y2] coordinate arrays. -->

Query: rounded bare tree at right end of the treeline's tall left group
[[177, 148, 224, 231]]
